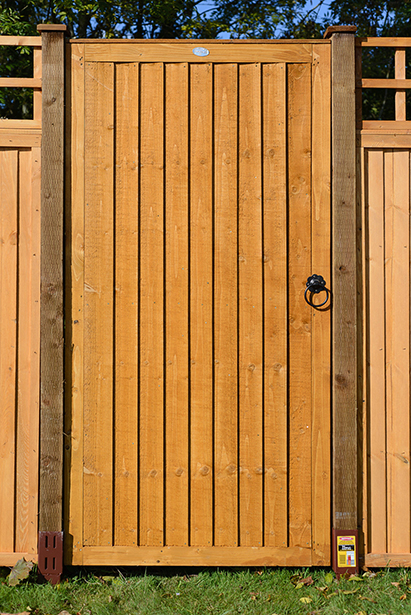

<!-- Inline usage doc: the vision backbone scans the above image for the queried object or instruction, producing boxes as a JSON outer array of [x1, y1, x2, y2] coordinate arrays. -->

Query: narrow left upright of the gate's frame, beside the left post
[[65, 43, 85, 565]]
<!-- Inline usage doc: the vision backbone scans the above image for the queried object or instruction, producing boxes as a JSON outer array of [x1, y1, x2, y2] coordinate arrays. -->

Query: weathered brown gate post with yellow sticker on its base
[[324, 26, 358, 573]]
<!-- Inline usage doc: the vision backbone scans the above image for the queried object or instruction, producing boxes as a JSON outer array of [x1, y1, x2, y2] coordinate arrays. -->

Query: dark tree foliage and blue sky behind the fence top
[[0, 0, 411, 119]]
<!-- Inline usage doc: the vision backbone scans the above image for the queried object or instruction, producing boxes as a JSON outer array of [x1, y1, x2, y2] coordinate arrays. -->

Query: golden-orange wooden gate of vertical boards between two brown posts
[[65, 41, 330, 565]]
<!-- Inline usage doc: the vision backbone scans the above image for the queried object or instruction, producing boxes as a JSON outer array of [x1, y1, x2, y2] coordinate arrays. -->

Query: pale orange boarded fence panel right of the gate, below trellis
[[360, 137, 411, 565]]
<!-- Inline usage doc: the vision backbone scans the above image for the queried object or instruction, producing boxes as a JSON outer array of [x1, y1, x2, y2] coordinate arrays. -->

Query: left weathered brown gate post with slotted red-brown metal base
[[37, 24, 66, 583]]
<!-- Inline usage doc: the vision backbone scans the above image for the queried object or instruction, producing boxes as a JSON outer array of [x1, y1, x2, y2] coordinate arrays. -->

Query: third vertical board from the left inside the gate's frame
[[139, 63, 165, 546]]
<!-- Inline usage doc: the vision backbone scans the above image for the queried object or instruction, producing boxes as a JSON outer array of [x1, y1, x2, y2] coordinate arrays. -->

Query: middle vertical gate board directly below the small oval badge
[[190, 64, 214, 546]]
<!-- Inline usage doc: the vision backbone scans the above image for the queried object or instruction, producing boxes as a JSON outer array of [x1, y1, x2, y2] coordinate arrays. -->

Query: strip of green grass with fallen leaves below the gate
[[0, 568, 411, 615]]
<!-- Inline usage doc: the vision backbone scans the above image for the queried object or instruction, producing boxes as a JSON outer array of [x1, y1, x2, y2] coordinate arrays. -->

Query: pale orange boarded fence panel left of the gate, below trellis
[[0, 143, 40, 565]]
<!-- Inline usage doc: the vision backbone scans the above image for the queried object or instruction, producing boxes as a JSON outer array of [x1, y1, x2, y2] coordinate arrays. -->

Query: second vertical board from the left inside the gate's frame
[[114, 64, 140, 545]]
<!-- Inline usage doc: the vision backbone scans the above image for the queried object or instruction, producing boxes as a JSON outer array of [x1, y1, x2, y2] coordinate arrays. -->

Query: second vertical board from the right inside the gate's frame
[[262, 63, 288, 547]]
